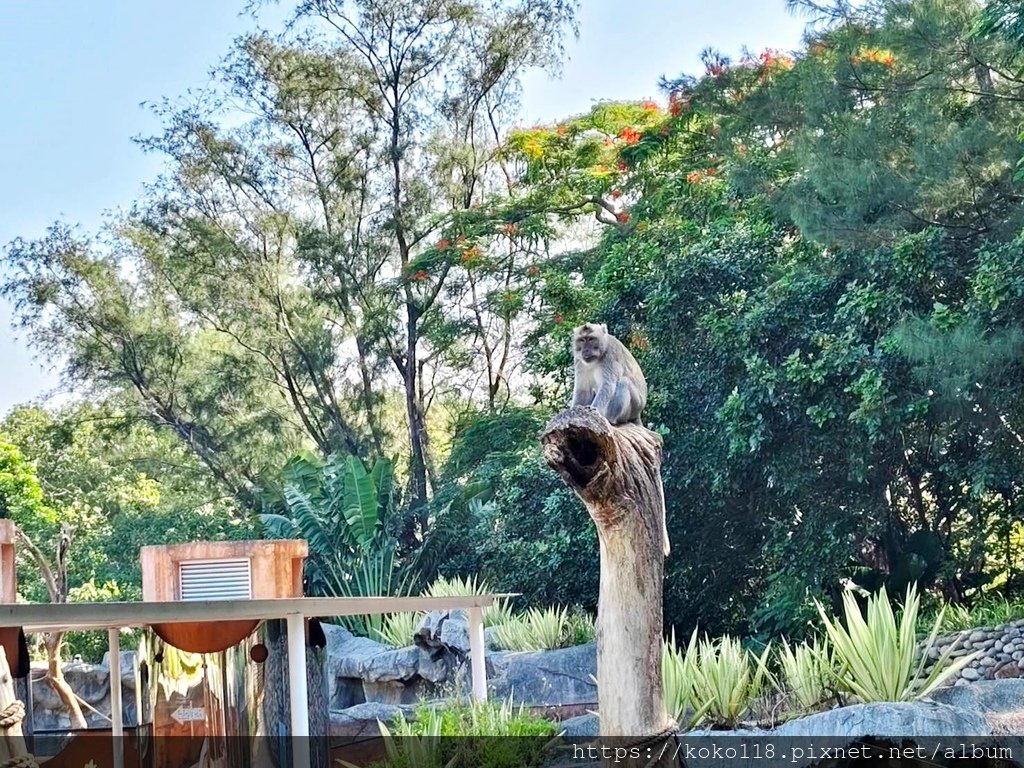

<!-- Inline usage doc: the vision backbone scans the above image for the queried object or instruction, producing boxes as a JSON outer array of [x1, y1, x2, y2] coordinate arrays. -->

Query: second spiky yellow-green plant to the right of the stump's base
[[692, 635, 772, 726]]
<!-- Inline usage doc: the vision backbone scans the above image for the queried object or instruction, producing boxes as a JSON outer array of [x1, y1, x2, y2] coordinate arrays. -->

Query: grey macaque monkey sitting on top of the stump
[[572, 323, 647, 424]]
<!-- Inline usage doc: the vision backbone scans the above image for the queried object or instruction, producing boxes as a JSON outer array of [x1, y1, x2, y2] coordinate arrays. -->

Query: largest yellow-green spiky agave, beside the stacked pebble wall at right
[[815, 585, 978, 702]]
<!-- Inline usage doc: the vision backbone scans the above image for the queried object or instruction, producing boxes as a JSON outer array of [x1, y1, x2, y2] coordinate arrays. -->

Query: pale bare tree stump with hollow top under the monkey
[[541, 407, 673, 753]]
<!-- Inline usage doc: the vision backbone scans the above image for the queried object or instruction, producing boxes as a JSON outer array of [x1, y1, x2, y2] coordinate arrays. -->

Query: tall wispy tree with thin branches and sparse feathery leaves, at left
[[5, 0, 573, 547]]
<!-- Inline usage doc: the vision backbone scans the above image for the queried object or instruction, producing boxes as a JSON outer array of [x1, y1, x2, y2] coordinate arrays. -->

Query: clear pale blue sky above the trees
[[0, 0, 804, 414]]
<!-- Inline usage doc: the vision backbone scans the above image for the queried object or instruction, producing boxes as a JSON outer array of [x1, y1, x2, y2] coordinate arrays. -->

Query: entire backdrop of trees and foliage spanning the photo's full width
[[0, 0, 1024, 655]]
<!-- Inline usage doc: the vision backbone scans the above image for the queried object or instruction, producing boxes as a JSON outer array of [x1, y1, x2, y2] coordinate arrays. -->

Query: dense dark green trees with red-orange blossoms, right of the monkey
[[425, 2, 1024, 634]]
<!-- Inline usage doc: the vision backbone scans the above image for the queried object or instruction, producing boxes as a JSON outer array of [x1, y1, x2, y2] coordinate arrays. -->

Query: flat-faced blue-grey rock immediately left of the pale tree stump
[[486, 643, 597, 708]]
